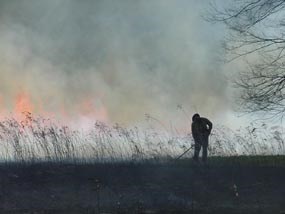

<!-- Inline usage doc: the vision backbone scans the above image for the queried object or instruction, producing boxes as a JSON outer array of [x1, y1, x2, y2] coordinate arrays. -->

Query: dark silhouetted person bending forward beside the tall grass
[[191, 113, 213, 162]]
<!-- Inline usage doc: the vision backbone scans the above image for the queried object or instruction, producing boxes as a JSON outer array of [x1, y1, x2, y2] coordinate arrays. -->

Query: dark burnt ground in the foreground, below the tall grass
[[0, 156, 285, 213]]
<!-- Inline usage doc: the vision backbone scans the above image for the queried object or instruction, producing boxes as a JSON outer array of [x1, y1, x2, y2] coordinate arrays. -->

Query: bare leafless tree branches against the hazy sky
[[208, 0, 285, 116]]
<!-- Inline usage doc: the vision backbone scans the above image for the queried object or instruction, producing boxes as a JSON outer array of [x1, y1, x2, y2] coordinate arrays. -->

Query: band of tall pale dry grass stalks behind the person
[[0, 113, 285, 163]]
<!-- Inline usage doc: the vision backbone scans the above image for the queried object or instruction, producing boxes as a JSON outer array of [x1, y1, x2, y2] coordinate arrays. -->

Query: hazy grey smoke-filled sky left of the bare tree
[[0, 0, 231, 127]]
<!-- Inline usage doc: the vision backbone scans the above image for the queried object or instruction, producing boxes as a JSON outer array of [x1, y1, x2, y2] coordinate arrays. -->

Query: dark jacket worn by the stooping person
[[191, 117, 213, 140]]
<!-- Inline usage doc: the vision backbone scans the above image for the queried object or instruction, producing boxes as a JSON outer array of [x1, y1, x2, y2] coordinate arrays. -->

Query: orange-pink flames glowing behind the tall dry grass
[[0, 91, 109, 126]]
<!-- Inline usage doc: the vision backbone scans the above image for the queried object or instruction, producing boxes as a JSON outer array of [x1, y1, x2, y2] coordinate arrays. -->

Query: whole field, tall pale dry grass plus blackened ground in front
[[0, 116, 285, 214]]
